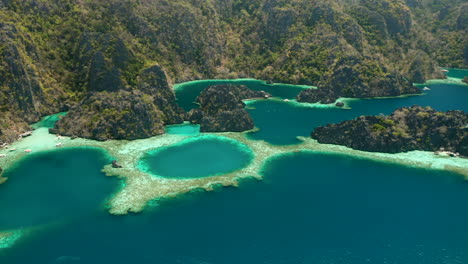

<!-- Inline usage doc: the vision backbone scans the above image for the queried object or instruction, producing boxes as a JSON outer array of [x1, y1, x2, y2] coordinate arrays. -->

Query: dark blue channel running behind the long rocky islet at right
[[248, 84, 468, 145]]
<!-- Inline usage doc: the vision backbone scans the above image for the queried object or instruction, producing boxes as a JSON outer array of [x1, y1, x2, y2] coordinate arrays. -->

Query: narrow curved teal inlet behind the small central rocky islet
[[174, 79, 311, 111]]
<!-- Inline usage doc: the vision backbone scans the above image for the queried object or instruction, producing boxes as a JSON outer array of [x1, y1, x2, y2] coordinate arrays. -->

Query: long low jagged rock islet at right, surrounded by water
[[311, 106, 468, 156]]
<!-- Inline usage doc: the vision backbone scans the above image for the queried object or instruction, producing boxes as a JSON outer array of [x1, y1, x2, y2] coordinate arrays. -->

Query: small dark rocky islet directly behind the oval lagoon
[[188, 85, 269, 132]]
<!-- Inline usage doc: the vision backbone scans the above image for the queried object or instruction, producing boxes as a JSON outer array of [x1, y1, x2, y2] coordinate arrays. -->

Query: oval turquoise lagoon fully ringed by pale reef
[[139, 136, 253, 179]]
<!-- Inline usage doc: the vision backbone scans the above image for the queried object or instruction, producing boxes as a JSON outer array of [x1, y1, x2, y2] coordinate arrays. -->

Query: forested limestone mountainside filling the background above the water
[[0, 0, 468, 141]]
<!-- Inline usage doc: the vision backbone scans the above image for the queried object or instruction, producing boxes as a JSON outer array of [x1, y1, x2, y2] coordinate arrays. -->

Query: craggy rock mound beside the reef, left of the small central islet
[[51, 66, 184, 140]]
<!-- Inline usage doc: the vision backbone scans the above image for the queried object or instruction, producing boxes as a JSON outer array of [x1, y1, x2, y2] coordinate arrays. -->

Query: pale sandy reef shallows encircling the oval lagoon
[[0, 128, 468, 218]]
